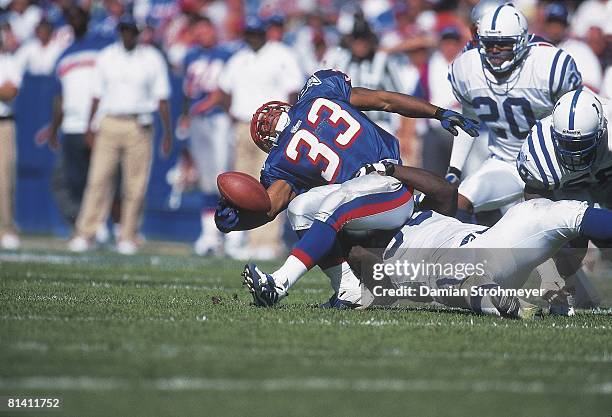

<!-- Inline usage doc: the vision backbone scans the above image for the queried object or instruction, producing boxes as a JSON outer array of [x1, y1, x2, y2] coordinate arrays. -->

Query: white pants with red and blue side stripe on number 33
[[287, 174, 414, 232]]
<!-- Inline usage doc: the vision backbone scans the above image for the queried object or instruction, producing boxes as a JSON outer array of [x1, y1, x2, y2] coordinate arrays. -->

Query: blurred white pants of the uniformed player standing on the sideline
[[189, 113, 234, 194]]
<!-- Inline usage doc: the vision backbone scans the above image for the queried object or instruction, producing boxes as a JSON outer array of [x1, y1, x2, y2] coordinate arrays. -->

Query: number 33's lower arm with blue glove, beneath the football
[[215, 180, 296, 233]]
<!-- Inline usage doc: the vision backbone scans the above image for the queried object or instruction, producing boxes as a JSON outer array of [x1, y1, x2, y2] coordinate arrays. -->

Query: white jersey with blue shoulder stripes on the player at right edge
[[516, 106, 612, 205]]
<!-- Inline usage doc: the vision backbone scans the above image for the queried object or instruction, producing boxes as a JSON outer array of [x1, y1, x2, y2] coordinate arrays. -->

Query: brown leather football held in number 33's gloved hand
[[217, 171, 271, 212]]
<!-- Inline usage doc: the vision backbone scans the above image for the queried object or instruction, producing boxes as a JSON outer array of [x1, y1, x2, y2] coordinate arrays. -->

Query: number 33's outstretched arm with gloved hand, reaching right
[[350, 87, 478, 137]]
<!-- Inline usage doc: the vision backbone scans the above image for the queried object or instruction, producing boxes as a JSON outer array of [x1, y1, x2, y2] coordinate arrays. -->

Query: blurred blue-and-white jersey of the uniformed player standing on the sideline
[[183, 46, 231, 114]]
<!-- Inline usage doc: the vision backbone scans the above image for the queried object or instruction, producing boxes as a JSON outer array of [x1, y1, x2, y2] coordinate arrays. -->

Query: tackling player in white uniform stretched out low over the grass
[[368, 194, 612, 317]]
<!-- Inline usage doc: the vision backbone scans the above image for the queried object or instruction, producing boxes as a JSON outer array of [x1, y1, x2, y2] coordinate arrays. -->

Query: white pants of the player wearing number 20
[[459, 157, 525, 213]]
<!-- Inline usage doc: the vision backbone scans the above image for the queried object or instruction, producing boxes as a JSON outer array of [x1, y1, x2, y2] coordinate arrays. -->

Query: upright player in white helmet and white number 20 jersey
[[449, 5, 582, 212]]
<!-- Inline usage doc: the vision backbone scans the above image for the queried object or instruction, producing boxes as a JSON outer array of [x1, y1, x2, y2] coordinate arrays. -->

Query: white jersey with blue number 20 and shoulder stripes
[[449, 42, 582, 162]]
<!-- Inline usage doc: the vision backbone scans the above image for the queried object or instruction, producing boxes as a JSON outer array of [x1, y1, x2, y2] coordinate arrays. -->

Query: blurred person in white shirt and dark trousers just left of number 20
[[420, 26, 465, 175]]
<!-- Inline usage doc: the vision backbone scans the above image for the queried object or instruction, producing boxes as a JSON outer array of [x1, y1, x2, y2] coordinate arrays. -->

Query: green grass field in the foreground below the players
[[0, 245, 612, 417]]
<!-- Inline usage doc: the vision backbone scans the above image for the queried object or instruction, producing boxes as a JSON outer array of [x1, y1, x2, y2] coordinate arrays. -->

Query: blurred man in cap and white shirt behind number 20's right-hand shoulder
[[544, 3, 602, 92]]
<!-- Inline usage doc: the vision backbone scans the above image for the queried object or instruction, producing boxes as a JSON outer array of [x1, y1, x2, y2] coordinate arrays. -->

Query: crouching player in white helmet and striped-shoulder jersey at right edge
[[516, 89, 612, 208]]
